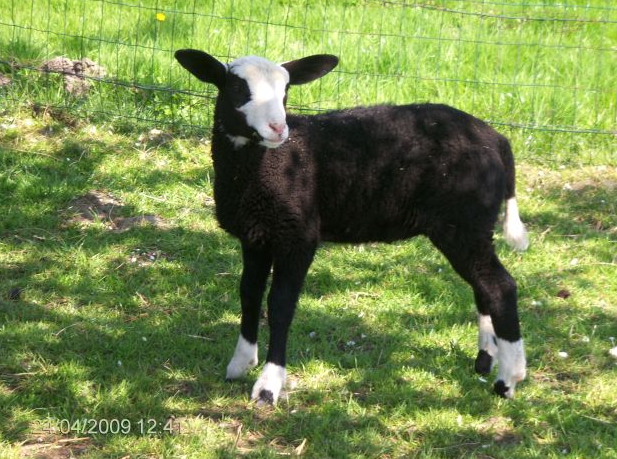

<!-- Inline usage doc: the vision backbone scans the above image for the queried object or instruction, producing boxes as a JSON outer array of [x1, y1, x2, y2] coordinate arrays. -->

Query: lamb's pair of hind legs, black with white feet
[[432, 237, 526, 397]]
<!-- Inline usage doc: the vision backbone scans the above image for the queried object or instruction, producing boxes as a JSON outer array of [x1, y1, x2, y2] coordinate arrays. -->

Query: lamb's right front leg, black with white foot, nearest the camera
[[251, 245, 315, 404]]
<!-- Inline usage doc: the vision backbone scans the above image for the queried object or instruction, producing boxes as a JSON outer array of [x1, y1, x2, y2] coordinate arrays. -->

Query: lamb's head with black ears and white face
[[175, 49, 338, 148]]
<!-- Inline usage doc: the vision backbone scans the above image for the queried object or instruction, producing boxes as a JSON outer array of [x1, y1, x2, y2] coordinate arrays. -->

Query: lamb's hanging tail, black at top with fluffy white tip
[[499, 137, 529, 252]]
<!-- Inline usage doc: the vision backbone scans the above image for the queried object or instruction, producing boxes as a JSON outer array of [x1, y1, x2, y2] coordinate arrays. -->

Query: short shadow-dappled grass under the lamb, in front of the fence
[[0, 104, 617, 458]]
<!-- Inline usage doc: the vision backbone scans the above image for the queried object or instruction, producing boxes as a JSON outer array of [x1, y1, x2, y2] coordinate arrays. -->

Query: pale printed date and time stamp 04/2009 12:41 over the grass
[[41, 418, 180, 435]]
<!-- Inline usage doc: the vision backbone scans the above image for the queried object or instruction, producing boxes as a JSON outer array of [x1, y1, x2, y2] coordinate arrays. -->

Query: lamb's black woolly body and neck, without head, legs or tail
[[212, 104, 514, 250]]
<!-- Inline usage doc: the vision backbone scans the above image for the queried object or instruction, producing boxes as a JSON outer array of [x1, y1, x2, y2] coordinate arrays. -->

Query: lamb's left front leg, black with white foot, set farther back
[[227, 244, 272, 379]]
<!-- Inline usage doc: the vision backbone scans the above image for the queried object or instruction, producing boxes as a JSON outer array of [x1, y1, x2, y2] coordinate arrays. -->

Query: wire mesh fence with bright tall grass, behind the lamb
[[0, 0, 617, 164]]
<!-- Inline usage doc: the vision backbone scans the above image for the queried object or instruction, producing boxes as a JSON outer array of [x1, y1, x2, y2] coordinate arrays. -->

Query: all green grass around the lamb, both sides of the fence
[[0, 0, 617, 459]]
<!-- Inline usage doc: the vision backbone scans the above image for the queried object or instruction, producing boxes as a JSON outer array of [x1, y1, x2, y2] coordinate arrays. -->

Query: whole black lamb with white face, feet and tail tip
[[175, 50, 528, 403]]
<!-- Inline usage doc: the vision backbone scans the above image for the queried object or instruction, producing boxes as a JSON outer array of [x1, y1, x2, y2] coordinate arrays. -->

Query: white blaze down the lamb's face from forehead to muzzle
[[229, 56, 289, 148]]
